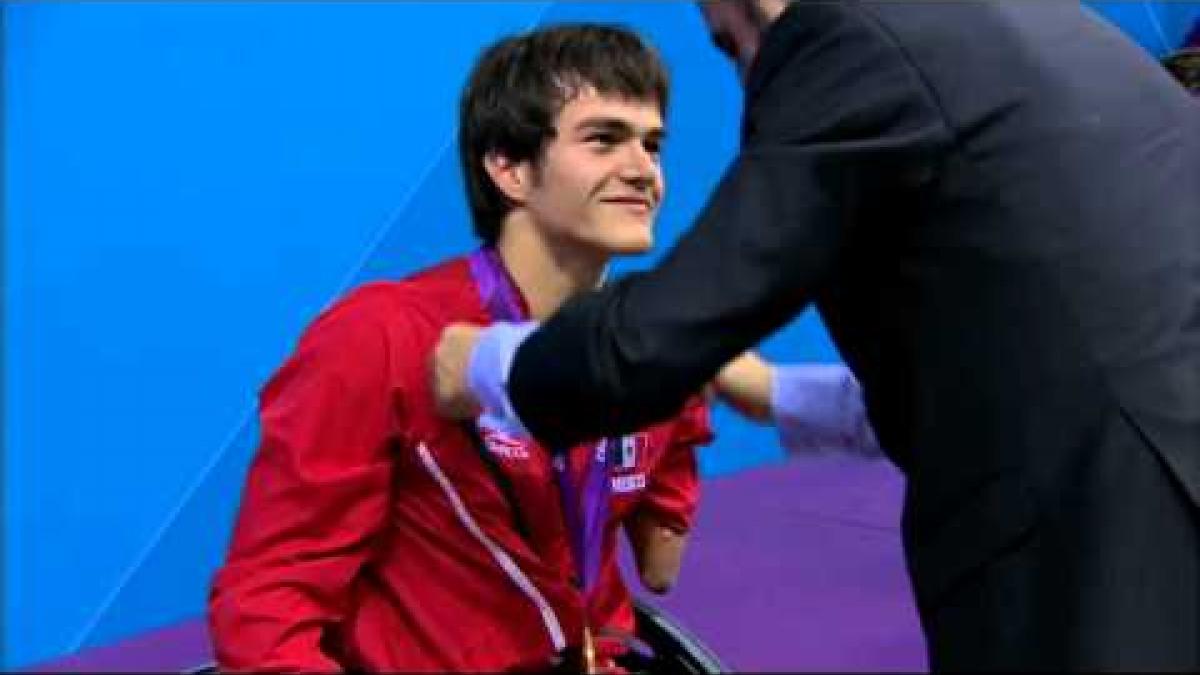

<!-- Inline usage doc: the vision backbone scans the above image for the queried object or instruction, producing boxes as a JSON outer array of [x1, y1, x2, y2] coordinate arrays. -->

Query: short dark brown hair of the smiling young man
[[458, 24, 668, 245]]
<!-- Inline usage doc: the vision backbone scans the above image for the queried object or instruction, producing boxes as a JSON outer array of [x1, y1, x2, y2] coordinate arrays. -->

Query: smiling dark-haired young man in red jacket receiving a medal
[[209, 25, 712, 671]]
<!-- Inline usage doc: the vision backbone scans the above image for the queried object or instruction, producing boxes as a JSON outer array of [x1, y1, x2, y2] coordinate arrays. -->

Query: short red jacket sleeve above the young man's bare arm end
[[637, 398, 713, 532]]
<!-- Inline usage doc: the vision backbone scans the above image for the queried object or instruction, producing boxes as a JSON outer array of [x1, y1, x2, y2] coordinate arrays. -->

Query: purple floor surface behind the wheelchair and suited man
[[31, 458, 926, 673]]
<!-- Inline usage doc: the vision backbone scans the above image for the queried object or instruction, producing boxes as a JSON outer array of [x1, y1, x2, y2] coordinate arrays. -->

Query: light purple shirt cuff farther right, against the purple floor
[[770, 364, 882, 456]]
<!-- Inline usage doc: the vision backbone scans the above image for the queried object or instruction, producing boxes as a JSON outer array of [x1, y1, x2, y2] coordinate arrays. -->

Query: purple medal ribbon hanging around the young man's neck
[[468, 246, 619, 595]]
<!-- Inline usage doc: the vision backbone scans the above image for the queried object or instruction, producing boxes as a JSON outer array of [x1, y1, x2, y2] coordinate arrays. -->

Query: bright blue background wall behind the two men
[[7, 2, 1200, 668]]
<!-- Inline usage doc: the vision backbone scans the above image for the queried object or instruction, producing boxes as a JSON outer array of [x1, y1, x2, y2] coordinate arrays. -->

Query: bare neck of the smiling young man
[[496, 216, 608, 319]]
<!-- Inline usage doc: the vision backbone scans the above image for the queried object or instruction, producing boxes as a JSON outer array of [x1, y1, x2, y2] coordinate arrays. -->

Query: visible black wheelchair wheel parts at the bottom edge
[[184, 598, 730, 675]]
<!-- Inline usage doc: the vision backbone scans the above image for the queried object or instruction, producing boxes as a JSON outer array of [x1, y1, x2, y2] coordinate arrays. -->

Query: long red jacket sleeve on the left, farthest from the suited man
[[209, 288, 408, 671]]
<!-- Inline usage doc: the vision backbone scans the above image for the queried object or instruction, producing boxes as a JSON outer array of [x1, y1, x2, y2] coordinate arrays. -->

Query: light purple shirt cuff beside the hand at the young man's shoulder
[[467, 321, 538, 438]]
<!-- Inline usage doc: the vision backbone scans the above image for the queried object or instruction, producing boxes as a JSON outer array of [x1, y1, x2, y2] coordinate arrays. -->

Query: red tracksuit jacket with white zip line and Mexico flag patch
[[209, 258, 712, 671]]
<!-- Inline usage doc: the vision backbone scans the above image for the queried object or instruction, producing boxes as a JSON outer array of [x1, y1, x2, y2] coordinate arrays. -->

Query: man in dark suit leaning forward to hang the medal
[[434, 0, 1200, 671]]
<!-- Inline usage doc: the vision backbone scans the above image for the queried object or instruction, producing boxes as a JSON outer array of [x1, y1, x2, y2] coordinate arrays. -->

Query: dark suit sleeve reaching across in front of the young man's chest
[[506, 4, 948, 447]]
